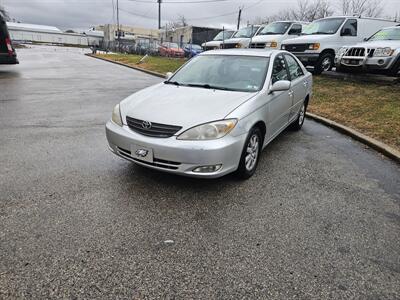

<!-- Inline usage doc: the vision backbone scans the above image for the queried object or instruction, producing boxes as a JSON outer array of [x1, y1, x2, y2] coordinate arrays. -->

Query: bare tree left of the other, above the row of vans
[[270, 0, 334, 22]]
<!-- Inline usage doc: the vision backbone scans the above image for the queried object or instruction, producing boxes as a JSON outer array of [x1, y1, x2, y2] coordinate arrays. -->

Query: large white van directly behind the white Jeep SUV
[[281, 16, 397, 74]]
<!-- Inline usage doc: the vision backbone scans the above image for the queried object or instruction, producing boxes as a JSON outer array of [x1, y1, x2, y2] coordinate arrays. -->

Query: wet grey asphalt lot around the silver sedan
[[0, 46, 400, 299]]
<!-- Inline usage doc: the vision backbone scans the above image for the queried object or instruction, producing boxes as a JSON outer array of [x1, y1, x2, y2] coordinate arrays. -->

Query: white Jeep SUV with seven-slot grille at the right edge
[[335, 26, 400, 75]]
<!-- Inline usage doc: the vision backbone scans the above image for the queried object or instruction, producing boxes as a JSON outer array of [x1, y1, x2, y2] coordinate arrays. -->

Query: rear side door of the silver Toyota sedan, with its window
[[284, 54, 308, 122]]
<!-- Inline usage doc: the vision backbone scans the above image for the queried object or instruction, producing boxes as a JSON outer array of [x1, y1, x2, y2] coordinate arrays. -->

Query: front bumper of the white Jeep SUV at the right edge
[[335, 56, 396, 70]]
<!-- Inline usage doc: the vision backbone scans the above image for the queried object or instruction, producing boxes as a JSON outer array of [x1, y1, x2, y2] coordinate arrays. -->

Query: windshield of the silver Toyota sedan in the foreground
[[165, 55, 269, 92]]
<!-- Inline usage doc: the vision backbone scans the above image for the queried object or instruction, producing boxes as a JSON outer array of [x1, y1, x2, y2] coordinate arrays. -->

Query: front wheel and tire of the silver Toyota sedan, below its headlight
[[236, 127, 263, 179]]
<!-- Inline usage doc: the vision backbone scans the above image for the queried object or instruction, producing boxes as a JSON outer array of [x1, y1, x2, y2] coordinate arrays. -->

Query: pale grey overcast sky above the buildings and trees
[[0, 0, 400, 29]]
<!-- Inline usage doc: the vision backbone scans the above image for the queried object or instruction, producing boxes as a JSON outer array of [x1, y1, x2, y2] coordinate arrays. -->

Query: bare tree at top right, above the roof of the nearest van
[[342, 0, 383, 17]]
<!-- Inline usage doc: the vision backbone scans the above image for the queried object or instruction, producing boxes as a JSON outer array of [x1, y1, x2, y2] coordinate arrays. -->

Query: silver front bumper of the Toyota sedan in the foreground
[[106, 121, 246, 178]]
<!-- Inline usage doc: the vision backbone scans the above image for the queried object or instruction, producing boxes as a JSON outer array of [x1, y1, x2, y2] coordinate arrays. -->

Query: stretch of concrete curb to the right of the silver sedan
[[306, 113, 400, 163]]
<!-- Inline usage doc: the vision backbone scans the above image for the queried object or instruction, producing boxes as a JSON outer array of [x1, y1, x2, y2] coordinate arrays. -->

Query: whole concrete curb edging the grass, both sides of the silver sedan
[[85, 53, 400, 163]]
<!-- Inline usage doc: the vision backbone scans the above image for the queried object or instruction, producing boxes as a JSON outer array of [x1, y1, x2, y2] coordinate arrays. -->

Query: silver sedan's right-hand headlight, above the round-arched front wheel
[[177, 119, 237, 140]]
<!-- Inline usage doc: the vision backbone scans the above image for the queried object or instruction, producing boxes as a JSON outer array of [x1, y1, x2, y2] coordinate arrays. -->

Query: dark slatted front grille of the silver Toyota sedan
[[126, 116, 182, 138]]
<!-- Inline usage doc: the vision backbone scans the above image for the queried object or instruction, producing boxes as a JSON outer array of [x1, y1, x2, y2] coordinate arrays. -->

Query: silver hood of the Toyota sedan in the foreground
[[120, 83, 257, 129]]
